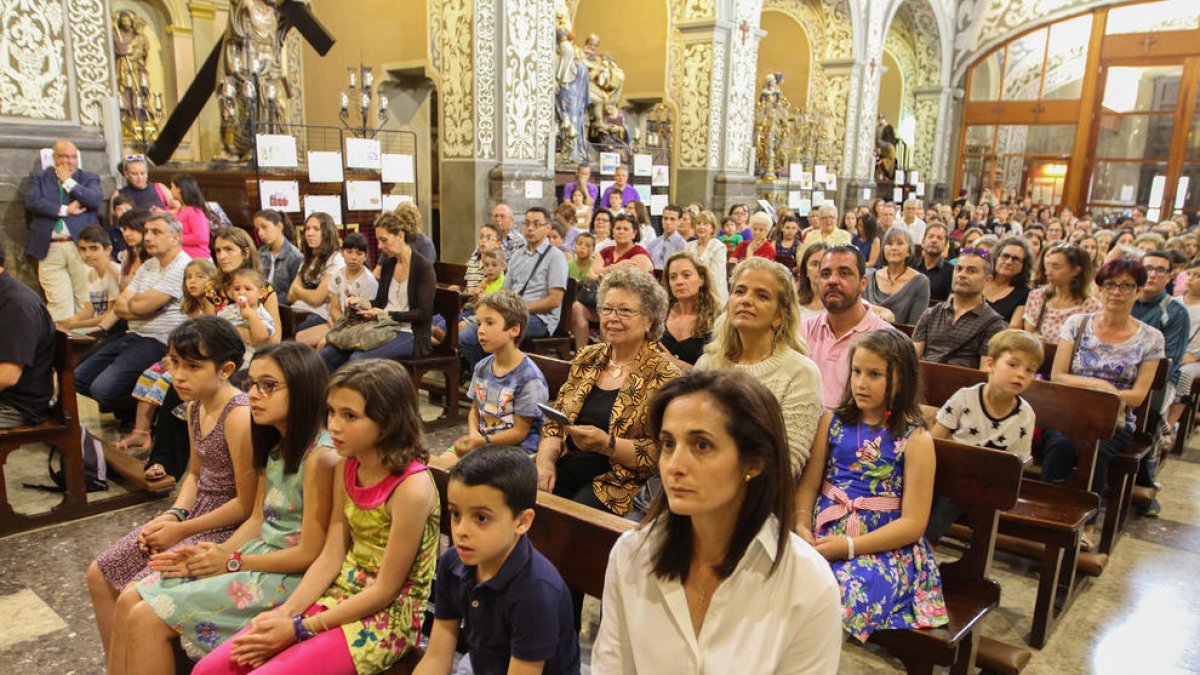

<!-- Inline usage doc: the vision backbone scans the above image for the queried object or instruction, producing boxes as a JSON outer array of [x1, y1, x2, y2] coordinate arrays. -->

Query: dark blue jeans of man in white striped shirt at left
[[76, 333, 167, 420]]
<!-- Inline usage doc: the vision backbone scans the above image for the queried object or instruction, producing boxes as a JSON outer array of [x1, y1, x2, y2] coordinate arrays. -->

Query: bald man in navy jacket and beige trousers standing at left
[[25, 141, 104, 321]]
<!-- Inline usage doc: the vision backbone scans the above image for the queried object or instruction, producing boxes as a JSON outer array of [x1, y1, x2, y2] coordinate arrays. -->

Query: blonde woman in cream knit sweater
[[696, 257, 822, 474]]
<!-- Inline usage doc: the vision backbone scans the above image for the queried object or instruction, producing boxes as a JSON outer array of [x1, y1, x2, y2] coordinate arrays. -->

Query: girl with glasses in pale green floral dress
[[109, 342, 341, 673]]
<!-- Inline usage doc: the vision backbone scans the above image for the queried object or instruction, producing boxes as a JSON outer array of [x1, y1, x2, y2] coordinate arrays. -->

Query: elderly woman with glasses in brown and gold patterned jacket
[[536, 268, 679, 515]]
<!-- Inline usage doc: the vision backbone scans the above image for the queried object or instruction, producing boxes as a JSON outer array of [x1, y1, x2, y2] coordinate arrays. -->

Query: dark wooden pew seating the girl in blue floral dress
[[870, 441, 1021, 674]]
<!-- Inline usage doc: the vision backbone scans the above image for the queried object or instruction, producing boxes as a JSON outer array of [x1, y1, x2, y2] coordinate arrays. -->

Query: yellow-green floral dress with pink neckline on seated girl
[[306, 458, 440, 675]]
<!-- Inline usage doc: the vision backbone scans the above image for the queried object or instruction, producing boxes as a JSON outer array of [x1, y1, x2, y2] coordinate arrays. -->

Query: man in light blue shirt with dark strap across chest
[[458, 207, 566, 371]]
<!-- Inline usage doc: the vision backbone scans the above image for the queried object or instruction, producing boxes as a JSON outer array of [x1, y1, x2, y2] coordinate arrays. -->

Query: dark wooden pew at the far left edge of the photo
[[0, 330, 175, 536]]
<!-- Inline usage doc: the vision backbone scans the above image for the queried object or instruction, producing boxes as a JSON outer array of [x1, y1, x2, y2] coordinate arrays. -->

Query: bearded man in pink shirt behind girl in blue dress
[[800, 245, 895, 410]]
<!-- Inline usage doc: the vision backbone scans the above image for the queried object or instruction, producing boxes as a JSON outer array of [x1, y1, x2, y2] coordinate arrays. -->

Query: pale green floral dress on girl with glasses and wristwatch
[[138, 432, 329, 661]]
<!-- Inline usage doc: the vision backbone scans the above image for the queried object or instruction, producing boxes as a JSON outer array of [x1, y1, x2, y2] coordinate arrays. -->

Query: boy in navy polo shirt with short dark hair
[[415, 446, 580, 675]]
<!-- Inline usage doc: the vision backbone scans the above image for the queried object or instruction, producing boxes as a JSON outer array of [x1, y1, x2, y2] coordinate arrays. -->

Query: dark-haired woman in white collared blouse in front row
[[592, 371, 841, 675]]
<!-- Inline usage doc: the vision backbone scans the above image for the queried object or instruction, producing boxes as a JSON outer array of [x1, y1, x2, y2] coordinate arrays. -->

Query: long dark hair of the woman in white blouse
[[642, 370, 796, 581]]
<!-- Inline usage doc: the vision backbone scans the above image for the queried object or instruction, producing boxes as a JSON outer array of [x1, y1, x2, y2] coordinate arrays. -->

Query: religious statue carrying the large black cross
[[218, 0, 290, 161]]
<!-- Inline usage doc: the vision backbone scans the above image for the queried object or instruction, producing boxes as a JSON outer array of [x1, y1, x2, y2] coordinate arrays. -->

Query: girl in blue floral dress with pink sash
[[797, 330, 947, 643]]
